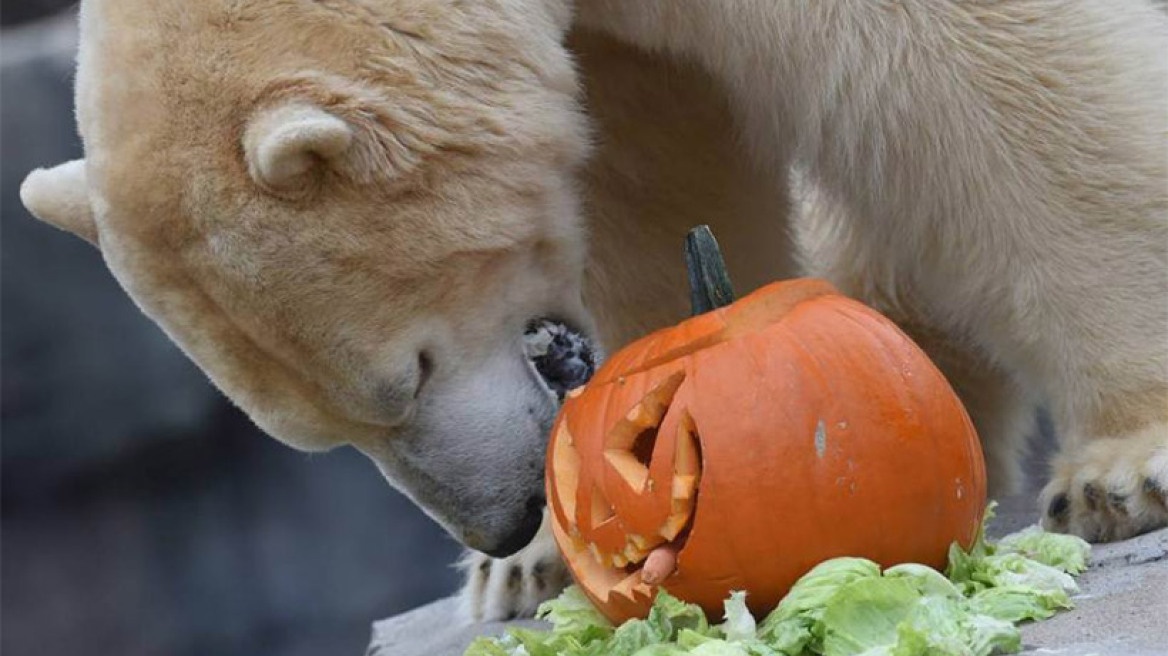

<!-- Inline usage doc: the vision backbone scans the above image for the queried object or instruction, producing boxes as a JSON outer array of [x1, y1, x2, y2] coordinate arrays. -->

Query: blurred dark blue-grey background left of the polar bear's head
[[0, 0, 460, 656]]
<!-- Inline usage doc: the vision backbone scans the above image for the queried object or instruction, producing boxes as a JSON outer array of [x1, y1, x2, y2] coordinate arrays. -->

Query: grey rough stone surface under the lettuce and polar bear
[[367, 497, 1168, 656]]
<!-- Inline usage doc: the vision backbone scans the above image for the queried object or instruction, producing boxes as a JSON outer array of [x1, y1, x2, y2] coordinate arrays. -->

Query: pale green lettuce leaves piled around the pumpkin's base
[[465, 505, 1090, 656]]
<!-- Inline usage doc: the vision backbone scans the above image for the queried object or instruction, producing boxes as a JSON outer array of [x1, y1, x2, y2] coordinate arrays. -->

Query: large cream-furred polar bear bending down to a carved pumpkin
[[22, 0, 1168, 617]]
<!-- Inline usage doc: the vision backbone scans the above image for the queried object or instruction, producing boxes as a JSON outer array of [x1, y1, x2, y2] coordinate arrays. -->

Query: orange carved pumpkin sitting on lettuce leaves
[[547, 227, 986, 622]]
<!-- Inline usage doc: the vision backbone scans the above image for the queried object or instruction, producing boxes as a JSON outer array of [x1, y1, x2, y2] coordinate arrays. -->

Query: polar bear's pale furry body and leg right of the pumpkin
[[478, 0, 1168, 616]]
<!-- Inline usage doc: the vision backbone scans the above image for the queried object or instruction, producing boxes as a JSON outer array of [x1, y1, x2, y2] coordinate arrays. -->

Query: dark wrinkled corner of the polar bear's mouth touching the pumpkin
[[523, 319, 596, 400]]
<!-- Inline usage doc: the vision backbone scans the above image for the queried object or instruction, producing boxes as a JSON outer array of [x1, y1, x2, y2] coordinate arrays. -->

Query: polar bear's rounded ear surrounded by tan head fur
[[243, 103, 357, 194]]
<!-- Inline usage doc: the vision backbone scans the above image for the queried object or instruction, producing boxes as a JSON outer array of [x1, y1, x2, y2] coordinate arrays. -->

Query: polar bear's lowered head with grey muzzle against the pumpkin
[[22, 0, 593, 556]]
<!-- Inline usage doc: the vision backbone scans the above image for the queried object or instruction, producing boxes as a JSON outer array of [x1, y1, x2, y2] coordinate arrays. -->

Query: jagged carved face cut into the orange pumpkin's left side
[[551, 370, 702, 607]]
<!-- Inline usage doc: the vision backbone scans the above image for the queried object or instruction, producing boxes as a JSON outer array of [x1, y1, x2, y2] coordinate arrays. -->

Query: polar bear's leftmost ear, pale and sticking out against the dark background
[[20, 160, 97, 246]]
